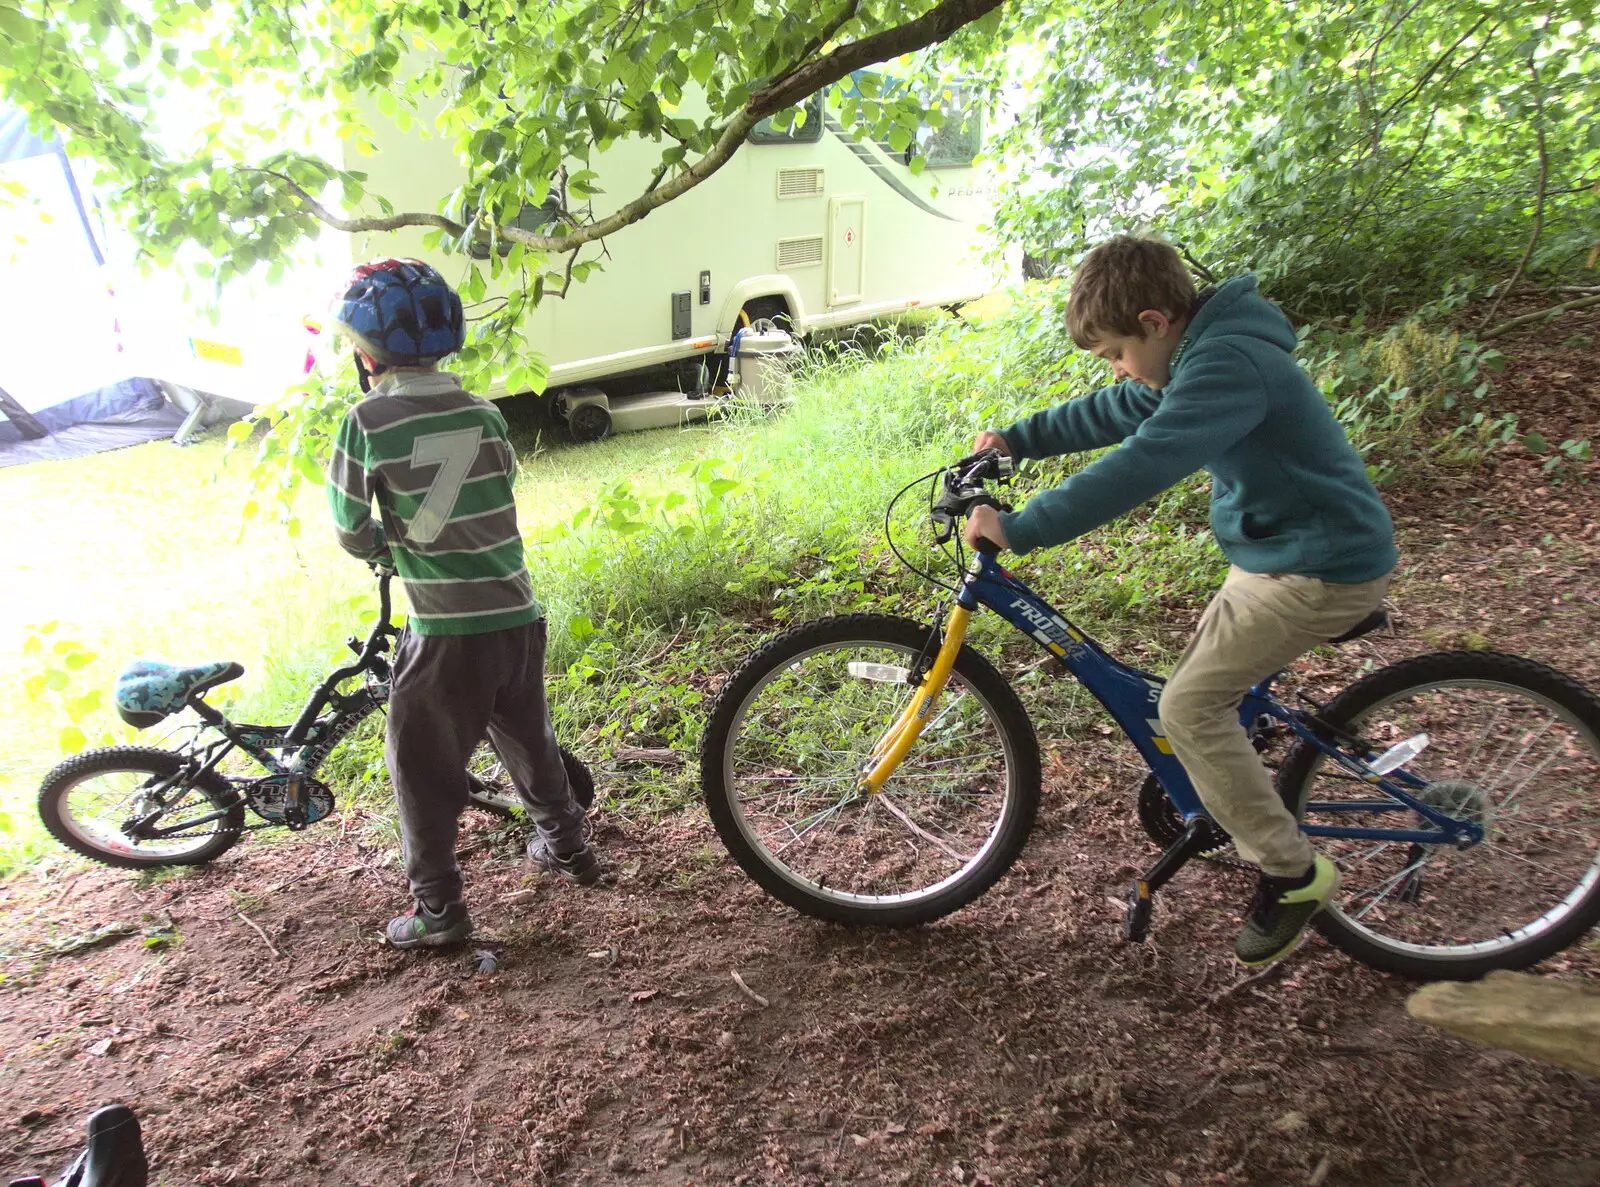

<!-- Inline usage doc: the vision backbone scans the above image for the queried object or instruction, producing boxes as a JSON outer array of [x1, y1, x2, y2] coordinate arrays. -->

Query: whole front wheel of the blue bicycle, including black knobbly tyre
[[701, 614, 1040, 926]]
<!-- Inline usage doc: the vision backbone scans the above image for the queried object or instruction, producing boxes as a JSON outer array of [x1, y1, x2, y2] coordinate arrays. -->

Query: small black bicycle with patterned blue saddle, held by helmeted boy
[[38, 571, 595, 869]]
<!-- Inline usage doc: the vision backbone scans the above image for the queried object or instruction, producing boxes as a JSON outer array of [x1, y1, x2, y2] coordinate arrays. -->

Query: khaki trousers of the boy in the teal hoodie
[[1160, 565, 1394, 877]]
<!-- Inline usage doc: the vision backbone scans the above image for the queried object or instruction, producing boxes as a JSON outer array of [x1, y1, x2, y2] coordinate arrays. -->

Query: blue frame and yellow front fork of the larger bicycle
[[861, 554, 1483, 845]]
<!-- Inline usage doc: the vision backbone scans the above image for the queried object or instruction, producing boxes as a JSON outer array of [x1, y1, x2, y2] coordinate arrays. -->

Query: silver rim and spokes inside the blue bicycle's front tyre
[[723, 638, 1018, 910]]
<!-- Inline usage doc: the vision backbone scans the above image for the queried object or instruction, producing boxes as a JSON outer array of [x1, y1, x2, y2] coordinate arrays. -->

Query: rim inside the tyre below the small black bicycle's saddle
[[61, 769, 232, 862]]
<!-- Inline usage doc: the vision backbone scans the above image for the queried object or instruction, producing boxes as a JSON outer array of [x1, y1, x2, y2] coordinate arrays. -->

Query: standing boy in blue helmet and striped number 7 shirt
[[328, 259, 600, 949]]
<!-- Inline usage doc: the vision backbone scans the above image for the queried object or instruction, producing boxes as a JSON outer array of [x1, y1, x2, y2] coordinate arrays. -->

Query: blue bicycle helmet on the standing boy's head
[[333, 259, 467, 366]]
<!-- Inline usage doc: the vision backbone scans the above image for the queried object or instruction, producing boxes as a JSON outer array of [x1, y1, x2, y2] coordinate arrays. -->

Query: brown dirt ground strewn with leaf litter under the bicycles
[[0, 307, 1600, 1187]]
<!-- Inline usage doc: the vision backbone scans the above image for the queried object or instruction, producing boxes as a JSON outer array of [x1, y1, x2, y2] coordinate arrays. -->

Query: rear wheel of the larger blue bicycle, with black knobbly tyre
[[1278, 651, 1600, 981]]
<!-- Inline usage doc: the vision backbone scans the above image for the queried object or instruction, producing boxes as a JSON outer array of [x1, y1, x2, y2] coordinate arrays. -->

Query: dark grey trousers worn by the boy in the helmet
[[384, 619, 584, 909]]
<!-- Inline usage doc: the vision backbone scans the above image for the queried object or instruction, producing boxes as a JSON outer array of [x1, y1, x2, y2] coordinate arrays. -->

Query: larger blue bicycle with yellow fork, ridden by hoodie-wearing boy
[[701, 451, 1600, 979]]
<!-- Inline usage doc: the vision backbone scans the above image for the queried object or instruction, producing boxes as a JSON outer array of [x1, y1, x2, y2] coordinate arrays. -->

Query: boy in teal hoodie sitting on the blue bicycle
[[966, 235, 1397, 965]]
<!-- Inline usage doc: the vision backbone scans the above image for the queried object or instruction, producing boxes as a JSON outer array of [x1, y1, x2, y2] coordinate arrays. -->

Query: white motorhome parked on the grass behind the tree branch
[[347, 77, 998, 438]]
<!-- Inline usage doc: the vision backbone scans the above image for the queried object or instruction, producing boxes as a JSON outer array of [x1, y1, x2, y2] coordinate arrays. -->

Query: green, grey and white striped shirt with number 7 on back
[[328, 371, 544, 635]]
